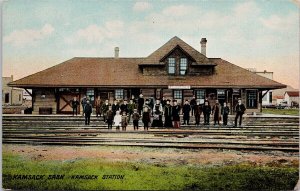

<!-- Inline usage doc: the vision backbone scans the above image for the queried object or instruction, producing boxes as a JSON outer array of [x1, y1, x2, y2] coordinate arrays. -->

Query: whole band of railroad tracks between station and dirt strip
[[2, 116, 299, 153]]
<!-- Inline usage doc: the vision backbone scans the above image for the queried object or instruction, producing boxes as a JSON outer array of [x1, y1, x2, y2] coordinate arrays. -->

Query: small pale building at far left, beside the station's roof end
[[2, 76, 23, 106]]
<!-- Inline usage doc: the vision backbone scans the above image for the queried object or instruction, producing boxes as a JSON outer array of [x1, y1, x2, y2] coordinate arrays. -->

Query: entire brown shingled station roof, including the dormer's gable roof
[[9, 37, 286, 89]]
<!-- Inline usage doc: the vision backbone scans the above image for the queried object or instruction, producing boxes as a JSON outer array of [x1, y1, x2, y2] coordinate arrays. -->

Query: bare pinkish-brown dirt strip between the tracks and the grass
[[2, 144, 299, 167]]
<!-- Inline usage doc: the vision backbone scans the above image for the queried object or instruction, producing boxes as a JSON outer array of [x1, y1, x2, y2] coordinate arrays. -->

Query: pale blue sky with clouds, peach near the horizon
[[2, 0, 300, 88]]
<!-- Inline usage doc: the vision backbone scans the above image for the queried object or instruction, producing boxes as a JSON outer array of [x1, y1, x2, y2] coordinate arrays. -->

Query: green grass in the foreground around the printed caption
[[3, 153, 298, 190]]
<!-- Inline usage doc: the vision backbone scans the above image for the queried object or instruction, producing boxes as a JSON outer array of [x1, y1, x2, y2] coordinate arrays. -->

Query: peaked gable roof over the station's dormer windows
[[141, 36, 209, 65]]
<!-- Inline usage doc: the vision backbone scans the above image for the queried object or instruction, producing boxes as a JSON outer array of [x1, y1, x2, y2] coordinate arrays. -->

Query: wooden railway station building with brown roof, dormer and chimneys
[[9, 36, 286, 114]]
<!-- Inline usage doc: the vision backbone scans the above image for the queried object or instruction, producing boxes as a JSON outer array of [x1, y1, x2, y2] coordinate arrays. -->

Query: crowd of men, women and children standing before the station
[[71, 94, 246, 131]]
